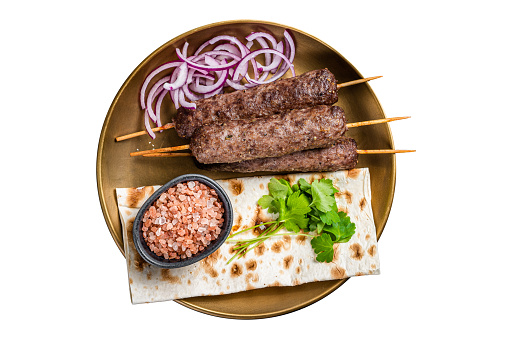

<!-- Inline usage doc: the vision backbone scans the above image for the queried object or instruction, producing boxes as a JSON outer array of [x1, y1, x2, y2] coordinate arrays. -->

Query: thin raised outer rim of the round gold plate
[[96, 19, 397, 319]]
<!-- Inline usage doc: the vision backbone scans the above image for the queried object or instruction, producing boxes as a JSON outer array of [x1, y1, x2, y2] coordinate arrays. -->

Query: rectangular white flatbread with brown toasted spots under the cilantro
[[116, 168, 380, 304]]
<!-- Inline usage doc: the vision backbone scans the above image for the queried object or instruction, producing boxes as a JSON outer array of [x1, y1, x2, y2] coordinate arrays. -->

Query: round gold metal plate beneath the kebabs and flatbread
[[97, 20, 396, 319]]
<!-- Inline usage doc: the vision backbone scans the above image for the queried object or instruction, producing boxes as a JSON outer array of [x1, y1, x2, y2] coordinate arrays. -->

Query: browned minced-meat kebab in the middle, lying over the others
[[190, 105, 347, 164]]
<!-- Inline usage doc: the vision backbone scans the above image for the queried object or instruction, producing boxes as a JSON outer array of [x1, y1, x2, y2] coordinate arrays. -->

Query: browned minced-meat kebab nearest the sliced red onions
[[175, 69, 338, 138]]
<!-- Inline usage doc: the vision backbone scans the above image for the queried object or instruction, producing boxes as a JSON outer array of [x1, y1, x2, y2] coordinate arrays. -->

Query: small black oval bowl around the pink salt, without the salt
[[133, 174, 233, 268]]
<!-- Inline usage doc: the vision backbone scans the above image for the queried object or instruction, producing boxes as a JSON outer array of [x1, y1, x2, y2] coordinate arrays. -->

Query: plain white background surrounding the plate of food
[[0, 0, 509, 338]]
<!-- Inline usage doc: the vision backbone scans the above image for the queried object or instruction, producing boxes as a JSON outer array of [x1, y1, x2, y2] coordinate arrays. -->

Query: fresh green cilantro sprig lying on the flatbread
[[227, 178, 355, 263]]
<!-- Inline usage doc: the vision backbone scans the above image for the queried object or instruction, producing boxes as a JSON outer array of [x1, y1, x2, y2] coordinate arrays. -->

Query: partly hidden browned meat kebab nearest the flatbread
[[199, 138, 358, 173]]
